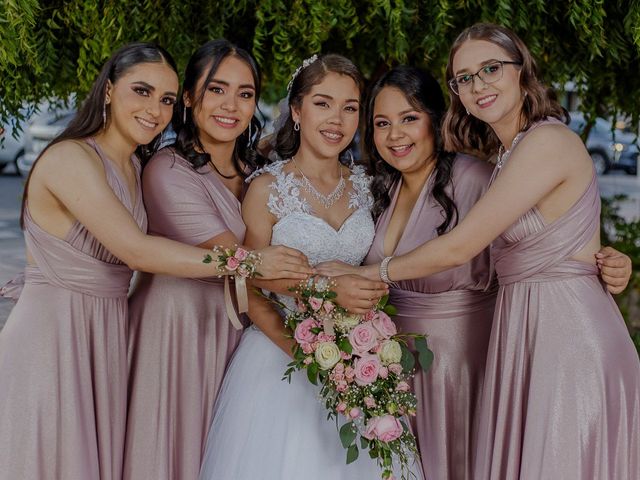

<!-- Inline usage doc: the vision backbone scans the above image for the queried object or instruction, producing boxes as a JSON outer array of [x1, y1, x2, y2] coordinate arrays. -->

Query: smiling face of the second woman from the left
[[185, 56, 256, 144]]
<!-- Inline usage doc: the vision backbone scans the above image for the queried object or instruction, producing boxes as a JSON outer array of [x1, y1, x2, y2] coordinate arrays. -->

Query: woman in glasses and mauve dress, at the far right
[[344, 24, 640, 480]]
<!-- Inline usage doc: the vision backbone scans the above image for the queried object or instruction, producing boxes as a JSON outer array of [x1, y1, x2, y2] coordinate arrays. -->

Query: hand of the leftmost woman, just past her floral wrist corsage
[[254, 245, 315, 280]]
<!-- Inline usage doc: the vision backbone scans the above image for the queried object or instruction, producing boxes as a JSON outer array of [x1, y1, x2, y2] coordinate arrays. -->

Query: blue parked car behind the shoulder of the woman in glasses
[[569, 112, 640, 175]]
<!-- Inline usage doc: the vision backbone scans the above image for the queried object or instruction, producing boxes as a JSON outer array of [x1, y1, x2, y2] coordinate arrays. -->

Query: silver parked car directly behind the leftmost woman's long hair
[[17, 108, 76, 176]]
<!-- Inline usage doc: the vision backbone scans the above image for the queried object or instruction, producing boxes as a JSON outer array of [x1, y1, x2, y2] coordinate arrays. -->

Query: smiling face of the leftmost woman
[[106, 62, 178, 145]]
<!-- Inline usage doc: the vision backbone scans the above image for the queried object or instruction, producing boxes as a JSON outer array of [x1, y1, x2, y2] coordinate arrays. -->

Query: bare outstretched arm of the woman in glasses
[[363, 126, 592, 280]]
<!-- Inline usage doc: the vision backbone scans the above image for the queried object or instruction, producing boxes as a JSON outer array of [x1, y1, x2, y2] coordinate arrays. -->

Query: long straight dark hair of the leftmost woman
[[20, 42, 178, 228]]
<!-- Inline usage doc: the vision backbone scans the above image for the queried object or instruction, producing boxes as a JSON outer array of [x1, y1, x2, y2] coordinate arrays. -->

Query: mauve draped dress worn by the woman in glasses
[[475, 121, 640, 480]]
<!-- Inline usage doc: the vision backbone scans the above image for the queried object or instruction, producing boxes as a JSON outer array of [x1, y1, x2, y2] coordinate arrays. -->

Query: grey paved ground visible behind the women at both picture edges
[[0, 172, 640, 329]]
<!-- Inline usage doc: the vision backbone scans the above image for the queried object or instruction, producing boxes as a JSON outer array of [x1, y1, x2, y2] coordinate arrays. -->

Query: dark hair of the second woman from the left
[[172, 39, 264, 176]]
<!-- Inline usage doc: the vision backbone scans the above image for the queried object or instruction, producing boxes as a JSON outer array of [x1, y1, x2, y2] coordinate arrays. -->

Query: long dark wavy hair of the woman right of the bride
[[365, 65, 458, 235]]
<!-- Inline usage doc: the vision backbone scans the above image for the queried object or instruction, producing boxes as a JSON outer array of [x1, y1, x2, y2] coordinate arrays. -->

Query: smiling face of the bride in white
[[291, 72, 360, 158]]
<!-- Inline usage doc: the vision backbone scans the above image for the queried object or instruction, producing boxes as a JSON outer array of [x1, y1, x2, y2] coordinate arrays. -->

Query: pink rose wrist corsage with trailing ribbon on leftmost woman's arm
[[203, 245, 262, 330]]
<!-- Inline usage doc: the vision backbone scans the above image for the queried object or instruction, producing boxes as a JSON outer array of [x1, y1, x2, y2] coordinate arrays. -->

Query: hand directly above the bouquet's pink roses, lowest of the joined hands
[[331, 274, 389, 314]]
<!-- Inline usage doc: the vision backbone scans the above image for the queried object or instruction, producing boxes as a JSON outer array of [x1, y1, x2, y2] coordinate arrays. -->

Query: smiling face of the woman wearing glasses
[[452, 40, 523, 130]]
